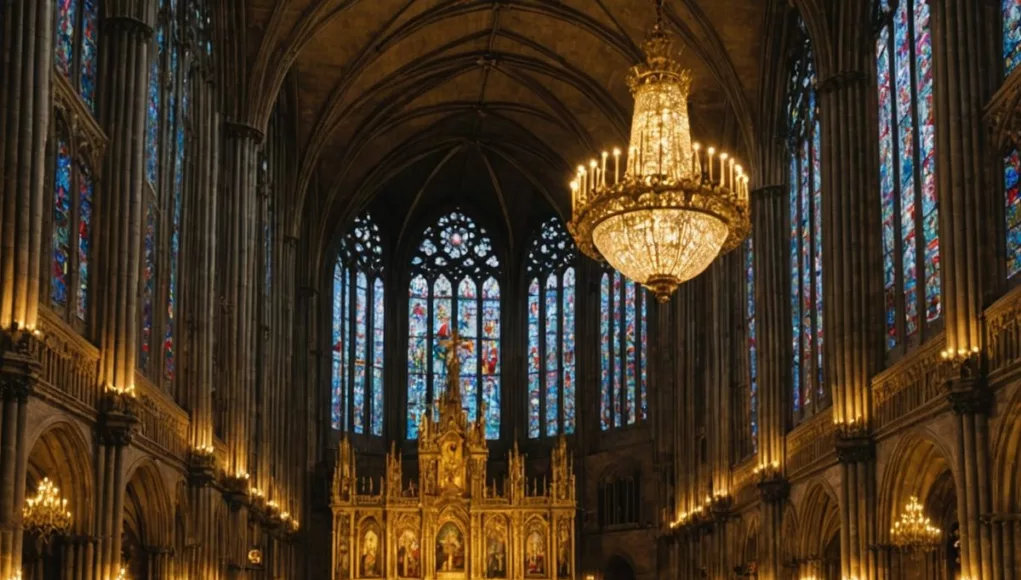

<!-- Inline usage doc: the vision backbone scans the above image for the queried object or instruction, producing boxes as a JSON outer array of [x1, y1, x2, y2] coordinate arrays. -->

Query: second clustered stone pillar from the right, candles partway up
[[818, 65, 881, 579]]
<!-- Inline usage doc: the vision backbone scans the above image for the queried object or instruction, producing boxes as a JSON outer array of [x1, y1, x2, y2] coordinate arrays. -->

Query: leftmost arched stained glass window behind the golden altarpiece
[[331, 213, 385, 436]]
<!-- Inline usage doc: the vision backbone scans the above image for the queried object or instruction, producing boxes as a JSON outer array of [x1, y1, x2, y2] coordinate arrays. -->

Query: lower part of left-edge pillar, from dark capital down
[[0, 331, 42, 578]]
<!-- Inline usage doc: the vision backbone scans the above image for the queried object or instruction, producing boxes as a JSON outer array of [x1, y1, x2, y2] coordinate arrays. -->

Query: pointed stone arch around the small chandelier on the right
[[877, 431, 960, 542]]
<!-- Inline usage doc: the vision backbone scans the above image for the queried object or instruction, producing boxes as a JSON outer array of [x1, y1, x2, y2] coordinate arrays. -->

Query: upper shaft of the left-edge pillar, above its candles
[[0, 0, 53, 330]]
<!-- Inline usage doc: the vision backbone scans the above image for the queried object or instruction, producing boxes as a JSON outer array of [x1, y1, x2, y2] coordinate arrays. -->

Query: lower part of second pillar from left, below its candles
[[93, 393, 138, 580]]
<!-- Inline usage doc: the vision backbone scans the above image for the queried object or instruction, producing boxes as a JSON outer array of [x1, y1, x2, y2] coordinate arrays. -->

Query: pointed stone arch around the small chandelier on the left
[[25, 415, 95, 534]]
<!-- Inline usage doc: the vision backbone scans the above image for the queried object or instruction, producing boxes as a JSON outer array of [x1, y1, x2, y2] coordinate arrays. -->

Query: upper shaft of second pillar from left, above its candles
[[94, 0, 155, 392]]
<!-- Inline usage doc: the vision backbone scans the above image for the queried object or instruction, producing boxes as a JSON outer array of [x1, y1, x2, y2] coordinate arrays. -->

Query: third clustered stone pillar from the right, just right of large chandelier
[[751, 185, 790, 580]]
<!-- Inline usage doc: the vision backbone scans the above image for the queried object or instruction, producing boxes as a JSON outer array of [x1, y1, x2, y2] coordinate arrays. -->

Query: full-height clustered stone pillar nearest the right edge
[[932, 0, 996, 580]]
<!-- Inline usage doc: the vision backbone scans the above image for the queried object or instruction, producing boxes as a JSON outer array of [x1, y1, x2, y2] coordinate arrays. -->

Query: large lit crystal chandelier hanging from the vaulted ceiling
[[568, 0, 751, 302]]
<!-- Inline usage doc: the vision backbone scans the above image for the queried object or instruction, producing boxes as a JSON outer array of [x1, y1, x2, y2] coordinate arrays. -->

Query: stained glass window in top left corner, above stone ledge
[[53, 0, 100, 112]]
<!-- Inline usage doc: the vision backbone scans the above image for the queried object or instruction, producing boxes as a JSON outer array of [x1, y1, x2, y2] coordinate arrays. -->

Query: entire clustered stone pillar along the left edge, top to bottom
[[0, 0, 53, 578]]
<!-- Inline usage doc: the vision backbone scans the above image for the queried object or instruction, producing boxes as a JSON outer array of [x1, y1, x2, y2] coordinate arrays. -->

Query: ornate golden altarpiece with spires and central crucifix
[[332, 336, 576, 580]]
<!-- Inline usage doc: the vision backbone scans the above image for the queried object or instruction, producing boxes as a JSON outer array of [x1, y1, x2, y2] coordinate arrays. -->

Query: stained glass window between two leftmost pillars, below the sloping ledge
[[50, 116, 96, 325]]
